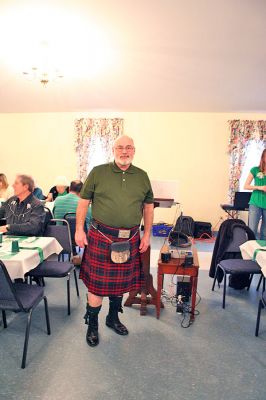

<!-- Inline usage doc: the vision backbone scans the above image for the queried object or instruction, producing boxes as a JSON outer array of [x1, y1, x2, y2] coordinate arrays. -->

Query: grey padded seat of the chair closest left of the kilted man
[[28, 261, 74, 278]]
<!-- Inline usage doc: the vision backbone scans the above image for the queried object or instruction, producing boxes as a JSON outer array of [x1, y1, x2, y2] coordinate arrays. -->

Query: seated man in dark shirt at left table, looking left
[[0, 175, 45, 236]]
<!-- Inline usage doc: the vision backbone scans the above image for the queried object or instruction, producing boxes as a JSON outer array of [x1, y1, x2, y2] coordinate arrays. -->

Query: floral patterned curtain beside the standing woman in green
[[228, 120, 266, 203]]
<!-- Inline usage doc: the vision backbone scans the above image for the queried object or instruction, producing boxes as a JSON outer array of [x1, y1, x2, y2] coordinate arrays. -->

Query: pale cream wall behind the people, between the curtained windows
[[0, 112, 266, 225]]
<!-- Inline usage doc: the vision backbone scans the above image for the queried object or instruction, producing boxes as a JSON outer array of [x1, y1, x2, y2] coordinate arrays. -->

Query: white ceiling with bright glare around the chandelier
[[0, 0, 266, 112]]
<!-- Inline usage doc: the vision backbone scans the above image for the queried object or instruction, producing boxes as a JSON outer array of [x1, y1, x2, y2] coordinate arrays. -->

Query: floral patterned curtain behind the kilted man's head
[[75, 118, 124, 182]]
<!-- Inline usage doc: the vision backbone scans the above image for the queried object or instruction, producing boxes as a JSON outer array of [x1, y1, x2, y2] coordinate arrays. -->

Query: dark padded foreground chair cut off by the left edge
[[0, 260, 51, 368]]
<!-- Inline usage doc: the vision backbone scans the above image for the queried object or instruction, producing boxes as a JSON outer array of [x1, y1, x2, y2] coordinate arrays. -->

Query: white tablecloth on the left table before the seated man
[[0, 236, 63, 279]]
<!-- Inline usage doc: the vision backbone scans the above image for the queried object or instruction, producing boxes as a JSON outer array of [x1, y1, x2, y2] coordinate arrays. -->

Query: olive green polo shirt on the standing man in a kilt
[[80, 162, 153, 228]]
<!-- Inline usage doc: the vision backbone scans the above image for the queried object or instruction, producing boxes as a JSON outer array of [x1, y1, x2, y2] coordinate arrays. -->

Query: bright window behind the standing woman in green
[[239, 140, 264, 192]]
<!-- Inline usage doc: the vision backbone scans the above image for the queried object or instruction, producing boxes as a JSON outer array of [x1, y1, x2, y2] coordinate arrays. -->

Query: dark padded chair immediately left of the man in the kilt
[[27, 219, 79, 315]]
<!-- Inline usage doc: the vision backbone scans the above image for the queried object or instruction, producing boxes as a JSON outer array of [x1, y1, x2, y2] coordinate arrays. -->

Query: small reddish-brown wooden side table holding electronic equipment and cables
[[156, 246, 199, 321]]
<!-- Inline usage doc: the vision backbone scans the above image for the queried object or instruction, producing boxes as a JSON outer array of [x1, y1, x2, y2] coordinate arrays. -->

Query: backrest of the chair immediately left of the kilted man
[[43, 218, 73, 255]]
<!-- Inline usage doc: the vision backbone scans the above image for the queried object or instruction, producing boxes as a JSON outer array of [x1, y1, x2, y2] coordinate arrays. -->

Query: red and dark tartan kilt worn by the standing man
[[79, 227, 144, 296]]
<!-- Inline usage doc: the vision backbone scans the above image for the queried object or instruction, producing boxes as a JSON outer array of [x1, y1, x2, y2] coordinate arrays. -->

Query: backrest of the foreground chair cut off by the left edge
[[0, 260, 24, 311]]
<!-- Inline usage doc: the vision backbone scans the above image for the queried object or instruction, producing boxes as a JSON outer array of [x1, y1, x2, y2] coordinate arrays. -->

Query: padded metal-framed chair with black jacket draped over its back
[[212, 226, 265, 308]]
